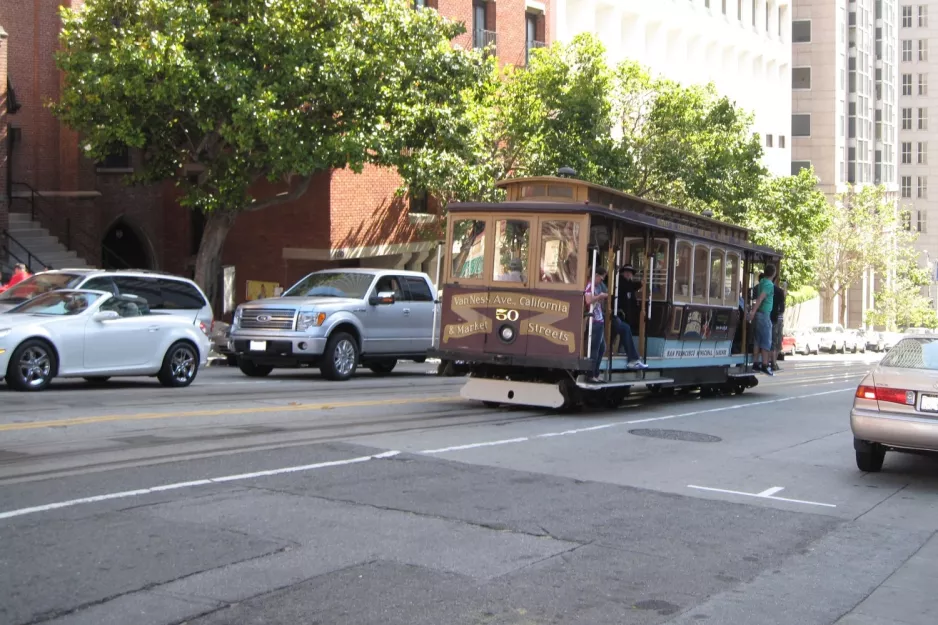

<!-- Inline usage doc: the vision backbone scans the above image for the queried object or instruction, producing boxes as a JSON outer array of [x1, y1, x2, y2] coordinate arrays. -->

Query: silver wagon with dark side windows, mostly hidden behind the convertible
[[0, 269, 214, 334]]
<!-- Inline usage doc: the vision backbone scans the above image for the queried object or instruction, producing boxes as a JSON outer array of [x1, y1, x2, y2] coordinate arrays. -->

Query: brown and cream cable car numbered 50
[[431, 170, 781, 408]]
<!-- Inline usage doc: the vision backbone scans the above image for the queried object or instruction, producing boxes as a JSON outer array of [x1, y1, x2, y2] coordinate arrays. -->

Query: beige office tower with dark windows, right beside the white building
[[791, 0, 900, 327]]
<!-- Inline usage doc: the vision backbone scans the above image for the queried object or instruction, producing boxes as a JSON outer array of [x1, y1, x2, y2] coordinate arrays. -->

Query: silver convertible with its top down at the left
[[0, 289, 210, 391]]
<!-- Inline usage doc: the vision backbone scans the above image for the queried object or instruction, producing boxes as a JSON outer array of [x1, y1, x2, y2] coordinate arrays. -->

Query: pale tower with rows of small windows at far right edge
[[899, 0, 938, 295]]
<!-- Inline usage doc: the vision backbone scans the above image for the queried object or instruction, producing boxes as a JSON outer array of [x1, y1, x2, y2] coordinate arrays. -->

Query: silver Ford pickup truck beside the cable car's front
[[228, 269, 438, 380]]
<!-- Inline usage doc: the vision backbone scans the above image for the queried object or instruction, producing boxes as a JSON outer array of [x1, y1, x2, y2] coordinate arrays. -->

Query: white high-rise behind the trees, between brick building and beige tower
[[551, 0, 792, 176]]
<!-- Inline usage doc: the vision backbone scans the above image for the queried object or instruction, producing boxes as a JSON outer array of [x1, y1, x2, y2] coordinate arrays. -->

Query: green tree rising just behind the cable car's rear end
[[738, 169, 833, 291]]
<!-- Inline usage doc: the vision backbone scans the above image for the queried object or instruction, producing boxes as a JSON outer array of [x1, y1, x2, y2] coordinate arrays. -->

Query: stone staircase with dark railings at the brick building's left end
[[0, 212, 89, 275]]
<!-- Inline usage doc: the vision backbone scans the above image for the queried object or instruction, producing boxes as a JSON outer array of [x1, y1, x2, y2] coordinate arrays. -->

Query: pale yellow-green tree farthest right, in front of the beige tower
[[815, 186, 908, 323]]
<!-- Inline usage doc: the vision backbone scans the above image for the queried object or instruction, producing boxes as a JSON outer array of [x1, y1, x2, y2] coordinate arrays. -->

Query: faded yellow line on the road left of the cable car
[[0, 397, 461, 432]]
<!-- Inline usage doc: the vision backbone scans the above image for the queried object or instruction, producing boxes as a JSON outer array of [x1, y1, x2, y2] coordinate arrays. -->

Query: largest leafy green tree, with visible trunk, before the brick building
[[54, 0, 485, 300]]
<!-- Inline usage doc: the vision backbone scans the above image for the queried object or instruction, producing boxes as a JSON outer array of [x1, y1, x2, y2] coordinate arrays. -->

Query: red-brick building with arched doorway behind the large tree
[[0, 0, 550, 312]]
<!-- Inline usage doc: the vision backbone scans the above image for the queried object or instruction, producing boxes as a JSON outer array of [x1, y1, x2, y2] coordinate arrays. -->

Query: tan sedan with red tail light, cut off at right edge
[[850, 334, 938, 472]]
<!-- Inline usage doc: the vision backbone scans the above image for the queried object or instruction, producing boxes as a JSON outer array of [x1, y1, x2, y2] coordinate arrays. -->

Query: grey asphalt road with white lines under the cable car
[[0, 356, 938, 625]]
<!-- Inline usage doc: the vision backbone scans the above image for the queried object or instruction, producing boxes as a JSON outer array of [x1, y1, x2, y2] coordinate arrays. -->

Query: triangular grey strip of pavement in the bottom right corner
[[835, 534, 938, 625]]
